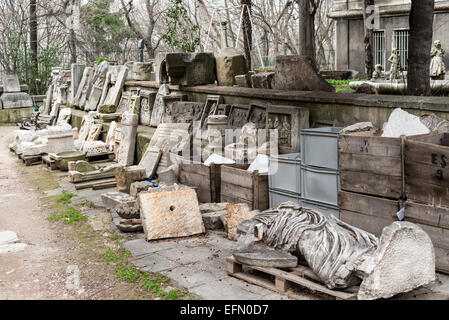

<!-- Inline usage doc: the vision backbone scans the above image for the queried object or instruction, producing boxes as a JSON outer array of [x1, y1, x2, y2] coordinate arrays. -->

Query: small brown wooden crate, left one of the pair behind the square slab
[[179, 160, 221, 203]]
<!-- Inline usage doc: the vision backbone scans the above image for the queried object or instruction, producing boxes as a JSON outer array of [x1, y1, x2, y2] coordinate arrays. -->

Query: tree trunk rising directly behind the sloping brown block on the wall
[[296, 0, 317, 69]]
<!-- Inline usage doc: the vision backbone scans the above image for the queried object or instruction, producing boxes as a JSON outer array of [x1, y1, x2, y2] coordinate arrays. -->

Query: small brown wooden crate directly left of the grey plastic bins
[[221, 165, 270, 211]]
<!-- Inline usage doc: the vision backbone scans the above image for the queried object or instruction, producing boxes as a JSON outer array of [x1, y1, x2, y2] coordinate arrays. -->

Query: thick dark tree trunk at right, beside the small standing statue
[[407, 0, 435, 96]]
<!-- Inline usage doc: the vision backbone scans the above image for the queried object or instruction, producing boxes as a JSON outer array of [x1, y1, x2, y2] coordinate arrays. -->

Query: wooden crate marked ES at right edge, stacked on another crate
[[404, 133, 449, 206]]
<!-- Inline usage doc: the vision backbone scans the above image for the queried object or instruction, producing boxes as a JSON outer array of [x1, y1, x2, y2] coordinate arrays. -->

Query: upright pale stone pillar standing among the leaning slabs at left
[[118, 111, 139, 167]]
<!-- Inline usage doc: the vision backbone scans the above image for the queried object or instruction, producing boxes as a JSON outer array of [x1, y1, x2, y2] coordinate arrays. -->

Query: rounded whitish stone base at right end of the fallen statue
[[357, 222, 436, 300]]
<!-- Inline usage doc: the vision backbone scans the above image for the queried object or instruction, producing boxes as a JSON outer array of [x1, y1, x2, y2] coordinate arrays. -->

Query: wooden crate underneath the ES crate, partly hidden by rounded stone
[[405, 200, 449, 273]]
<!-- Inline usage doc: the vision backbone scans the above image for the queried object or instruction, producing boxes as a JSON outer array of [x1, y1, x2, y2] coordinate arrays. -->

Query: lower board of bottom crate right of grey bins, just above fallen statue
[[340, 210, 397, 237]]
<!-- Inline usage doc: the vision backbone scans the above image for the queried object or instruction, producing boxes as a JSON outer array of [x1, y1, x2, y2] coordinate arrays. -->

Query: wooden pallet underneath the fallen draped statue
[[226, 257, 359, 300]]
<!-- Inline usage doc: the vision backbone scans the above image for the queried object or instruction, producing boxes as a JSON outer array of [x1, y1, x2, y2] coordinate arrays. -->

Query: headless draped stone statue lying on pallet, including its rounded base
[[234, 203, 435, 299]]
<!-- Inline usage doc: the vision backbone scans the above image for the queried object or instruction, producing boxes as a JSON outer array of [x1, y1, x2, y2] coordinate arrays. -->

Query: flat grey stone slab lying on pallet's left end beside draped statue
[[234, 249, 298, 268]]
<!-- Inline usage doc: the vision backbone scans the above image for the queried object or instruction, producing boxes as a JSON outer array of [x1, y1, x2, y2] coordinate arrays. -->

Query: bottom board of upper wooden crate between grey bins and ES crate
[[340, 171, 403, 199]]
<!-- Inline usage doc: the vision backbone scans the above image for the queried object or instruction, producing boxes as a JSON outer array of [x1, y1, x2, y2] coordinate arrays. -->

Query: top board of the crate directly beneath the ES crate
[[405, 201, 449, 229]]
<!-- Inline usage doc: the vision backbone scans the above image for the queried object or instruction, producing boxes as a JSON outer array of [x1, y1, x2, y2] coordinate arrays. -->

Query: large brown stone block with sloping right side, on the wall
[[274, 55, 335, 92]]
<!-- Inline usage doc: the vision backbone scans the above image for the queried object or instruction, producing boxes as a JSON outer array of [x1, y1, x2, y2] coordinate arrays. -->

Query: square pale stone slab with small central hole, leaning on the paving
[[138, 188, 205, 241]]
